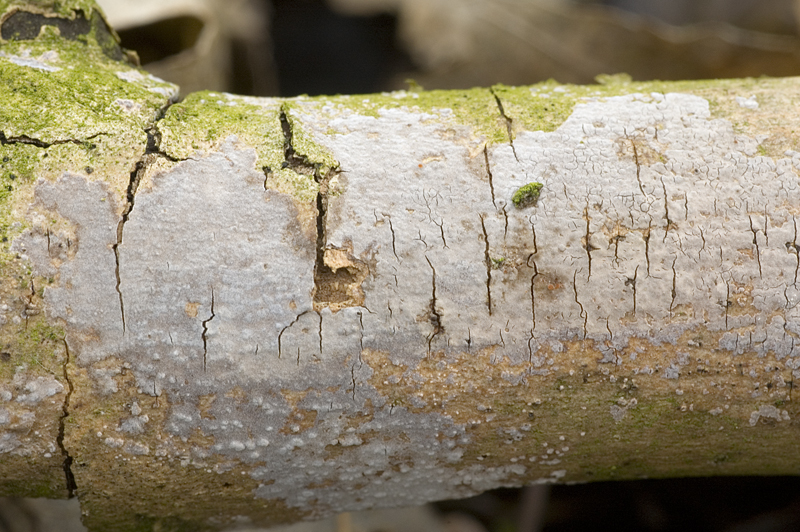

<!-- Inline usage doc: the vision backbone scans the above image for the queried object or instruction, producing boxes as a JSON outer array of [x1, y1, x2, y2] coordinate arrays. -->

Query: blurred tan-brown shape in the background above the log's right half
[[331, 0, 800, 88]]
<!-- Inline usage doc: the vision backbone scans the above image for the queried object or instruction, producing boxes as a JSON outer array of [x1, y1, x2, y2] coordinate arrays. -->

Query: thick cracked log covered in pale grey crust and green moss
[[6, 4, 800, 530]]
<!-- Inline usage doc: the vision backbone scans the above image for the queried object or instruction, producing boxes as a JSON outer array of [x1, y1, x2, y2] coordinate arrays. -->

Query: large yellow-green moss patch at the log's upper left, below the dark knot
[[0, 31, 175, 143]]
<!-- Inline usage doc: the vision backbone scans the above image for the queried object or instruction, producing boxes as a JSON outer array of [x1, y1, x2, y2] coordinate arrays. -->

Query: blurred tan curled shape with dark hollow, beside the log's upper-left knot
[[98, 0, 277, 95]]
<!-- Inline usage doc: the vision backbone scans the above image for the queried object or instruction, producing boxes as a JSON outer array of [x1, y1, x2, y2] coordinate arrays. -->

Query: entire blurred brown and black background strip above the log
[[95, 0, 800, 96]]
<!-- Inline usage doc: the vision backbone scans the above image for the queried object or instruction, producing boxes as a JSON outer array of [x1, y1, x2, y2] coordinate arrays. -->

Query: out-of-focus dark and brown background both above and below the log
[[7, 0, 800, 532]]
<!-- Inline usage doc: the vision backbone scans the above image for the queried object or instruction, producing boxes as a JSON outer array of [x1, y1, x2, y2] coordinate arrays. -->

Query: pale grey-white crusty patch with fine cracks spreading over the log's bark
[[14, 94, 800, 512]]
